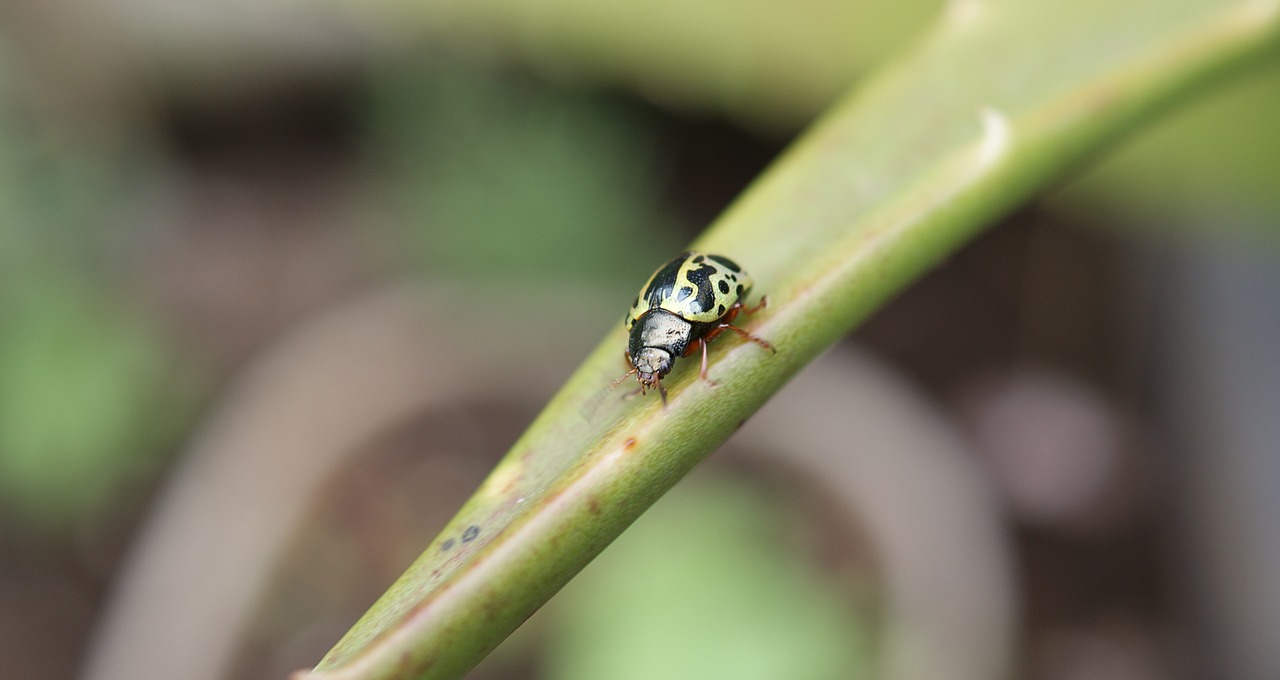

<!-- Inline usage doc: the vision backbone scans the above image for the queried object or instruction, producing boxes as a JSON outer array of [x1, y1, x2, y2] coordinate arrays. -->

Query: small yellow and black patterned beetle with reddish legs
[[613, 251, 776, 406]]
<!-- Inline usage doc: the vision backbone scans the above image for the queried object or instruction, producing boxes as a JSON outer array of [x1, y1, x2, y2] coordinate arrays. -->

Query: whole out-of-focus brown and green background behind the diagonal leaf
[[0, 0, 1280, 680]]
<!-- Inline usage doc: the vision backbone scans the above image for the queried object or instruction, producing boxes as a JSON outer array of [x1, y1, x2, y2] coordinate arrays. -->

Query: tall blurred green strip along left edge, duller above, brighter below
[[0, 45, 184, 530]]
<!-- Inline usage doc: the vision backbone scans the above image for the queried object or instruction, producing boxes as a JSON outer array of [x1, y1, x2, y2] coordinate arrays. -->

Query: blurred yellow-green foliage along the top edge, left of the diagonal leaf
[[342, 0, 943, 131]]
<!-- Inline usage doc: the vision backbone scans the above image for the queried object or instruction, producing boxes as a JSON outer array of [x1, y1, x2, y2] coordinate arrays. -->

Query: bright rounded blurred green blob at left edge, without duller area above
[[0, 269, 177, 526]]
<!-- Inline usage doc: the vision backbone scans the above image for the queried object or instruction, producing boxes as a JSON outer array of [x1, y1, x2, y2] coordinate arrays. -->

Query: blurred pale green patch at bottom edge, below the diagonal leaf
[[545, 476, 874, 680]]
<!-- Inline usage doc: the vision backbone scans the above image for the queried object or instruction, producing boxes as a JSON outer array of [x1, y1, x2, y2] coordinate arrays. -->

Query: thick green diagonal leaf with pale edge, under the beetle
[[298, 0, 1280, 679]]
